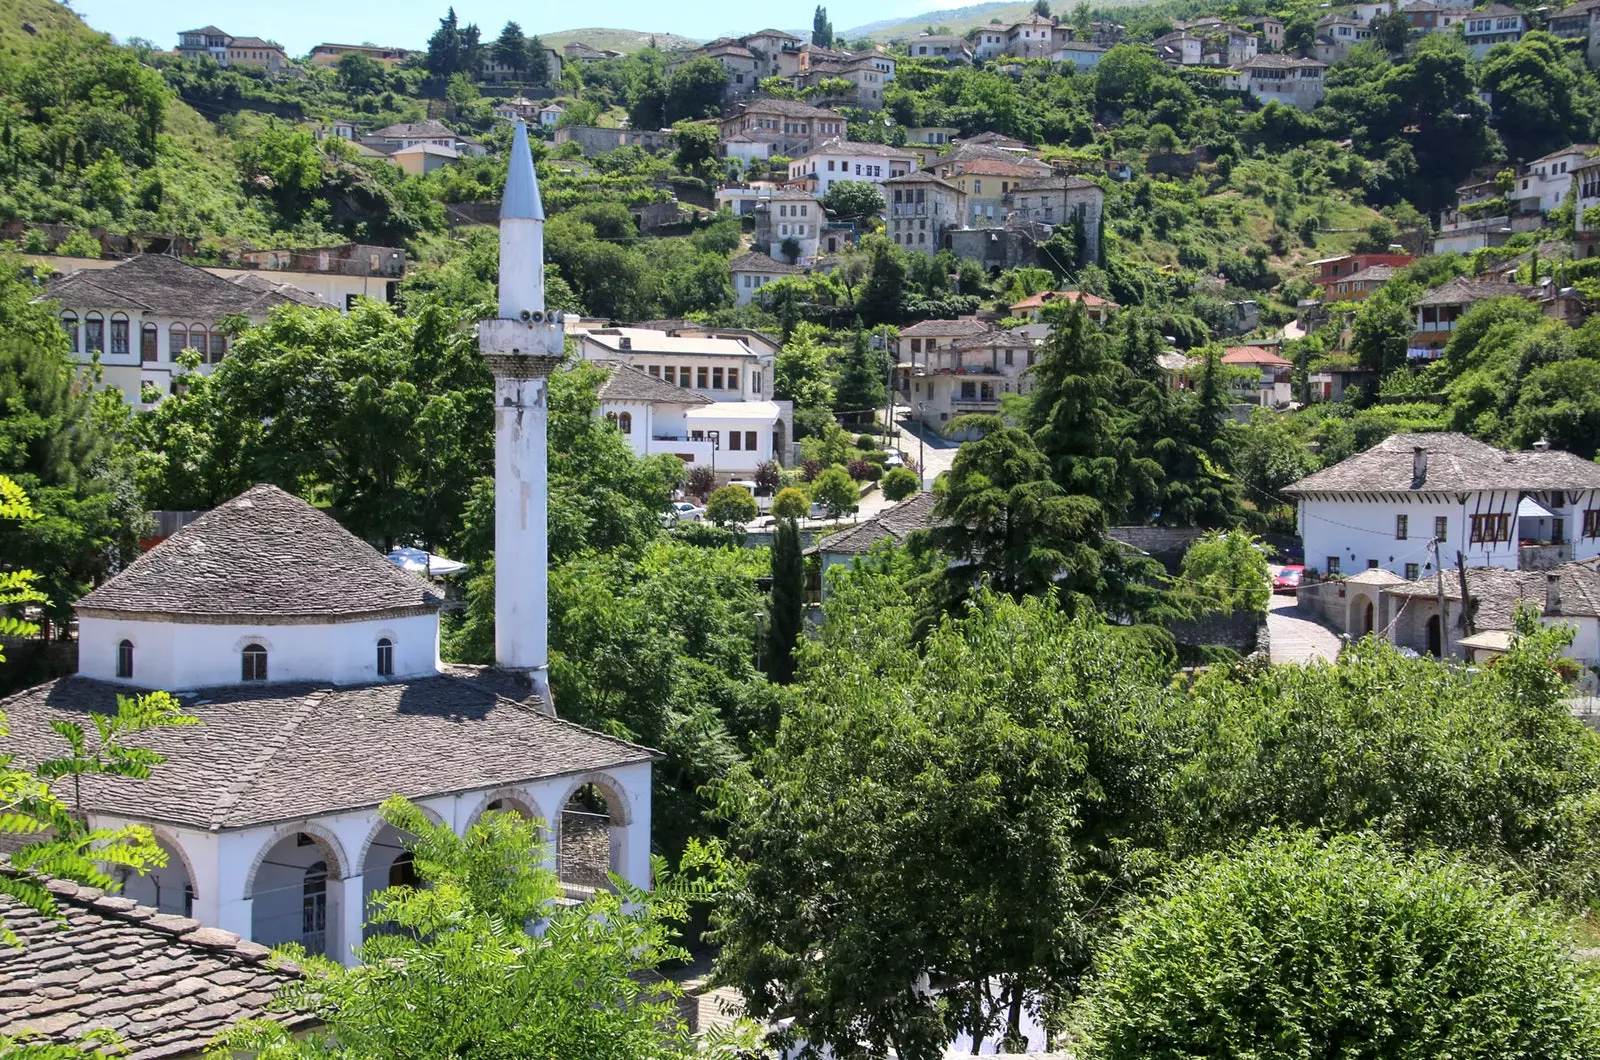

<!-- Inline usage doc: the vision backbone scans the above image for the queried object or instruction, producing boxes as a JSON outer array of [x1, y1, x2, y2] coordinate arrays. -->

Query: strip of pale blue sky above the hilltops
[[72, 0, 940, 56]]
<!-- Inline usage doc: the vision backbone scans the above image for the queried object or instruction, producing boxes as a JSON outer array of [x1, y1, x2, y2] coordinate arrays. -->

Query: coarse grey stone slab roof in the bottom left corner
[[0, 882, 314, 1060]]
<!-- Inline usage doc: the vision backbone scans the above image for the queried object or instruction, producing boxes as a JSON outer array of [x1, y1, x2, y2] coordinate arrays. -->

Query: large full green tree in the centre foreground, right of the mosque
[[712, 592, 1163, 1060]]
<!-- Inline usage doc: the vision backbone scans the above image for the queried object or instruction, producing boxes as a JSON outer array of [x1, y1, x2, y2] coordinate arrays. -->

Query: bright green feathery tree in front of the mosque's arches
[[222, 796, 750, 1060]]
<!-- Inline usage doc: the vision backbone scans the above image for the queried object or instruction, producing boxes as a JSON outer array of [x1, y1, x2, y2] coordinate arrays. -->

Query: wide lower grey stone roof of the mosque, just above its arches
[[0, 669, 658, 829]]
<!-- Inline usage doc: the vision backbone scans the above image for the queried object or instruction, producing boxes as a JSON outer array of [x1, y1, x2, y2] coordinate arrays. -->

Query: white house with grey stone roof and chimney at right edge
[[1285, 434, 1600, 580]]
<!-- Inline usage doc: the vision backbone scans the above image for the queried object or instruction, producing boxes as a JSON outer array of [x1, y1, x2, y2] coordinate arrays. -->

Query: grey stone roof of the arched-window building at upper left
[[45, 255, 328, 320]]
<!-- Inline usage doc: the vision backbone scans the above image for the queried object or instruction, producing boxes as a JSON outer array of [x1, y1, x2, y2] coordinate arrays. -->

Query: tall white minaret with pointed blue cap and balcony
[[478, 122, 565, 705]]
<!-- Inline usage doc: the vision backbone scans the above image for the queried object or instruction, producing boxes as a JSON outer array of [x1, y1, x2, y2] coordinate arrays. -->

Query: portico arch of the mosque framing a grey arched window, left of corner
[[250, 833, 344, 958]]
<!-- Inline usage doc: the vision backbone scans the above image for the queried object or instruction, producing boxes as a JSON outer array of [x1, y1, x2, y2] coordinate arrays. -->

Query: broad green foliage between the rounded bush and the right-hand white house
[[1170, 612, 1600, 903]]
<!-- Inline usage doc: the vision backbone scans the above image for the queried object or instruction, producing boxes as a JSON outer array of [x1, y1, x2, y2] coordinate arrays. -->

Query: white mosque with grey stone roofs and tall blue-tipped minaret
[[5, 123, 656, 962]]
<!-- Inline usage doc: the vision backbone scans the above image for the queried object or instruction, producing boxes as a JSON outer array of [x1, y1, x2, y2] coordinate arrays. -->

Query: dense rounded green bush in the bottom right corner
[[1086, 836, 1600, 1060]]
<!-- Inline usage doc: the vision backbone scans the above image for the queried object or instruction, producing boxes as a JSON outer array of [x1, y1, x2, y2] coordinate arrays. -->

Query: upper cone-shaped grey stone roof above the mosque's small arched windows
[[77, 485, 440, 621]]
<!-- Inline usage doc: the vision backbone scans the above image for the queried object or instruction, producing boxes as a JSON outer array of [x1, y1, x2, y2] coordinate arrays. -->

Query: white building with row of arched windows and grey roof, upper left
[[45, 255, 333, 407]]
